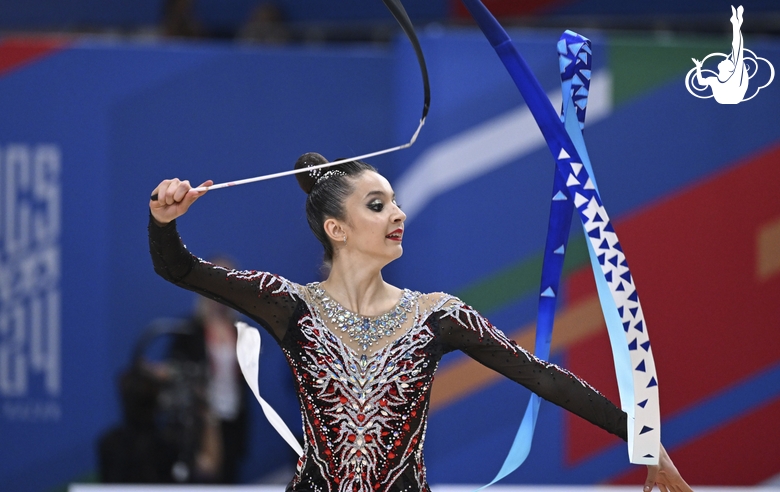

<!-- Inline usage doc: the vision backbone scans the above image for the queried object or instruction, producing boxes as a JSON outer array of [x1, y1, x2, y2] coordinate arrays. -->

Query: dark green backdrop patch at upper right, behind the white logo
[[608, 34, 731, 106]]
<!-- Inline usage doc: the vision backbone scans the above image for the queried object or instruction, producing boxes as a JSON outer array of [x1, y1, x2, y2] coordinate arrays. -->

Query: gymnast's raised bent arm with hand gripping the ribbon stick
[[149, 180, 298, 341]]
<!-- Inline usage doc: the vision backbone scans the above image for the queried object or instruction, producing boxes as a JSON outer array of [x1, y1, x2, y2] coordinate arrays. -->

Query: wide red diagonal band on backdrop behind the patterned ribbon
[[565, 145, 780, 472]]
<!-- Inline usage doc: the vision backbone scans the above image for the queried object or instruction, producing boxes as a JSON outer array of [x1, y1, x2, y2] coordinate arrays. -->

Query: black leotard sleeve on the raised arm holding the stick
[[148, 216, 300, 342]]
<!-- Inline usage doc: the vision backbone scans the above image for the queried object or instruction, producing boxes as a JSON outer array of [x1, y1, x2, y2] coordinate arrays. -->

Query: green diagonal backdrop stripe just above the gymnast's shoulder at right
[[457, 234, 590, 313]]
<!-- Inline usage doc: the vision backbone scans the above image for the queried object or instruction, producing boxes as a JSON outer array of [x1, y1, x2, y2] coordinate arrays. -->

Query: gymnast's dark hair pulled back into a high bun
[[295, 152, 377, 263]]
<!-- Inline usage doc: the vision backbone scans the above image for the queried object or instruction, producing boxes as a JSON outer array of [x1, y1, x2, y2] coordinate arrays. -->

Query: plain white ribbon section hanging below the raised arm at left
[[236, 321, 303, 456]]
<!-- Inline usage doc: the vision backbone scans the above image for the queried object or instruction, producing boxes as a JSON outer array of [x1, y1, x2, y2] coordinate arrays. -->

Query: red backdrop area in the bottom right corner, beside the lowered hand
[[609, 399, 780, 485]]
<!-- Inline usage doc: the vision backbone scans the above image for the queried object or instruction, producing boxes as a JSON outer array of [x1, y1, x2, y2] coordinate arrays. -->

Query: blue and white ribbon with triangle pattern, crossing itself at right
[[463, 0, 660, 488]]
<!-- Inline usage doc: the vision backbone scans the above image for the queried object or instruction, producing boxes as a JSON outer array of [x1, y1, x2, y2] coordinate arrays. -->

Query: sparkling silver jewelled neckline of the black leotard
[[306, 282, 416, 357]]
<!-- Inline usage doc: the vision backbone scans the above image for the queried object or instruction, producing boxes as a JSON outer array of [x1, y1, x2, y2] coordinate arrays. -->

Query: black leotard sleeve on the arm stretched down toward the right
[[429, 298, 628, 441]]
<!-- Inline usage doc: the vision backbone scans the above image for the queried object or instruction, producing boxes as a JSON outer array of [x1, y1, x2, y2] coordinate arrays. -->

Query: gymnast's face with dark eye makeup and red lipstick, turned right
[[342, 171, 406, 263]]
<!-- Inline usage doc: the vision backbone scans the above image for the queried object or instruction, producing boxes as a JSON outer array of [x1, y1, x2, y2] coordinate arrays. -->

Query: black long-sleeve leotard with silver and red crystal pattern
[[149, 220, 627, 492]]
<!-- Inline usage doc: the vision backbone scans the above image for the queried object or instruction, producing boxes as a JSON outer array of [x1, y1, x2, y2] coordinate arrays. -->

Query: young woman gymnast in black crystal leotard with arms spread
[[149, 153, 690, 492]]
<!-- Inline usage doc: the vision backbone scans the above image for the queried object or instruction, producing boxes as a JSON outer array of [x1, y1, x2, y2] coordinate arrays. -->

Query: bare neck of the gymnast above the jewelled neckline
[[321, 256, 400, 316]]
